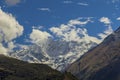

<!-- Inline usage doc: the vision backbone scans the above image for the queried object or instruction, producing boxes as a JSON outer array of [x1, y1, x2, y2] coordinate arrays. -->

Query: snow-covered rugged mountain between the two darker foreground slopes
[[9, 39, 97, 71]]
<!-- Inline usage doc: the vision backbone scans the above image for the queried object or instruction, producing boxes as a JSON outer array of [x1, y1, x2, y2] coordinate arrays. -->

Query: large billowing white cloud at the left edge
[[0, 9, 23, 53]]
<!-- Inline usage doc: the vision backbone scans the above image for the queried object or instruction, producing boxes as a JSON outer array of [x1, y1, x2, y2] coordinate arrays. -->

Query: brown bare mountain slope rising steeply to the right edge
[[67, 28, 120, 80]]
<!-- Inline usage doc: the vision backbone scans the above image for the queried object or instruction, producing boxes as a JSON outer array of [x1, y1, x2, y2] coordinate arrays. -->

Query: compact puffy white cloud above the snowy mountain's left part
[[30, 29, 52, 43]]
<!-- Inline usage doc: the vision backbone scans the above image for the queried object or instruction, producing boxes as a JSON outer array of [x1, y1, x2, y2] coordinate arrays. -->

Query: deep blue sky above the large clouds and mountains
[[0, 0, 120, 52]]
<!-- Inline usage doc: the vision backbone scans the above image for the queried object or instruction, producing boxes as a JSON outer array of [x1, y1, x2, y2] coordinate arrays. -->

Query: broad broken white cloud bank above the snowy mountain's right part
[[50, 19, 101, 43]]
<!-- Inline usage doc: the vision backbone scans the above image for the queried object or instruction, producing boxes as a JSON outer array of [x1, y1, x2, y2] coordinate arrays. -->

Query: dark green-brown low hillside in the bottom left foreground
[[0, 55, 77, 80]]
